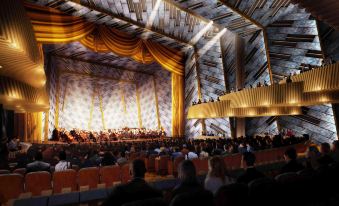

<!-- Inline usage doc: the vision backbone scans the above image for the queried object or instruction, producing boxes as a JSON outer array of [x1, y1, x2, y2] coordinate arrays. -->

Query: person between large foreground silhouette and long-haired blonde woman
[[172, 160, 203, 198]]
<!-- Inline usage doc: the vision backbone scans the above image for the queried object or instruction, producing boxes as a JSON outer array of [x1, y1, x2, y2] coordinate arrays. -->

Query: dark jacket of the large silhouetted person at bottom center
[[102, 178, 162, 206]]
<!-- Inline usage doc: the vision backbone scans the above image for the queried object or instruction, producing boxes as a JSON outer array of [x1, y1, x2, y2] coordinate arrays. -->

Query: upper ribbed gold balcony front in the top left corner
[[0, 0, 46, 88]]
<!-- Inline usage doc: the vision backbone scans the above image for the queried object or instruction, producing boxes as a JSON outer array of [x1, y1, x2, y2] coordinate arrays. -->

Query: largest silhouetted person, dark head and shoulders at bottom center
[[102, 159, 162, 206]]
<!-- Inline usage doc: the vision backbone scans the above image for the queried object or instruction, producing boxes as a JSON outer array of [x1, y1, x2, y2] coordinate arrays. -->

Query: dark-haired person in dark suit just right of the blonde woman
[[237, 152, 265, 184]]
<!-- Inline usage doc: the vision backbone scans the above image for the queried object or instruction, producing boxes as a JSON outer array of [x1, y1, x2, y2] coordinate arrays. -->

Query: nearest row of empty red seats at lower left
[[0, 165, 131, 203]]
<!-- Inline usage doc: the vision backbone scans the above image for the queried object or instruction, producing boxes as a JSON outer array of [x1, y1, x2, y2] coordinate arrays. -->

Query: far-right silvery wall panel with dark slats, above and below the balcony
[[267, 8, 336, 142]]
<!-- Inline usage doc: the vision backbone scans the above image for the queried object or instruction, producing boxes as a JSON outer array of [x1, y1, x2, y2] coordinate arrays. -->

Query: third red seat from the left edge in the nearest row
[[53, 169, 77, 193]]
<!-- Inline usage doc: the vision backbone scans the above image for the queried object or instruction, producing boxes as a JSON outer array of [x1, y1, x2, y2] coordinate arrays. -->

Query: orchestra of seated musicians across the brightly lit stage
[[52, 127, 166, 143]]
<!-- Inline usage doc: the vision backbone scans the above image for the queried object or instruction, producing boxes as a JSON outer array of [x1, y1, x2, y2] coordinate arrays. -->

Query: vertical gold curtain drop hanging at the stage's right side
[[172, 73, 185, 137]]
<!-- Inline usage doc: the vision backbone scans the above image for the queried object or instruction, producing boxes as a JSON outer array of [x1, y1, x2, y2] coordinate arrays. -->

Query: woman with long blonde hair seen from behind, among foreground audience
[[205, 157, 234, 194]]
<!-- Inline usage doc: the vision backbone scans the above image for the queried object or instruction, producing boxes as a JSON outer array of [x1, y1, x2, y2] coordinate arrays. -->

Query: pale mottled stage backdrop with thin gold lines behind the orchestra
[[48, 57, 172, 138]]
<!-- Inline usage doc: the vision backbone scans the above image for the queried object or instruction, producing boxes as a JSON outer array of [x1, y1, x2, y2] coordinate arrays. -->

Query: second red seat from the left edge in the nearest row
[[25, 171, 52, 196]]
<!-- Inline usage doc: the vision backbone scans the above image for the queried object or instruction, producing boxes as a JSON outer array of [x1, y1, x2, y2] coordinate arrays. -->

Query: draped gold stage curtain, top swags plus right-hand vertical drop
[[25, 2, 184, 136]]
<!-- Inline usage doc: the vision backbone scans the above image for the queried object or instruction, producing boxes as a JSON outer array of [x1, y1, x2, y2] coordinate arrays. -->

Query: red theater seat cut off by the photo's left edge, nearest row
[[0, 174, 24, 204]]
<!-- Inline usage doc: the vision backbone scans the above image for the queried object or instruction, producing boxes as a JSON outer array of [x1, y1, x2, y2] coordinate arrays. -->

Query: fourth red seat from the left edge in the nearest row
[[78, 167, 99, 189]]
